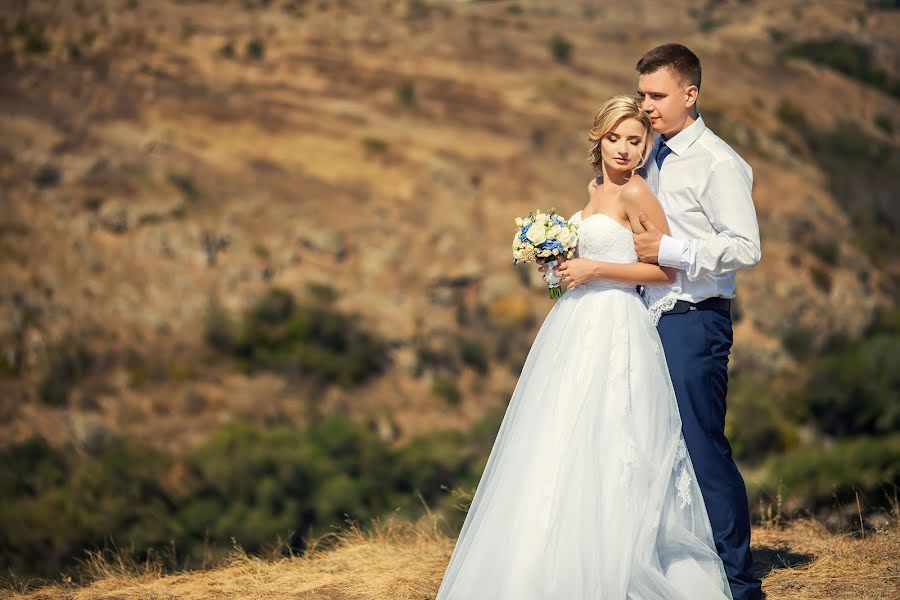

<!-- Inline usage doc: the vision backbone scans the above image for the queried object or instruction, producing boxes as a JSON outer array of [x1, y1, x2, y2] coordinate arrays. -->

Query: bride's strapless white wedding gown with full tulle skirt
[[437, 211, 731, 600]]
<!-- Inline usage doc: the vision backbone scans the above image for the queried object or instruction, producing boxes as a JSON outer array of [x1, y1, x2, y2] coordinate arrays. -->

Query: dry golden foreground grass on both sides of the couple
[[0, 515, 900, 600]]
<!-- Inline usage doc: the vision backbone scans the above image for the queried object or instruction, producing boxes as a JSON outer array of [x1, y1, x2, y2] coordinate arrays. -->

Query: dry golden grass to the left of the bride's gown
[[0, 516, 453, 600]]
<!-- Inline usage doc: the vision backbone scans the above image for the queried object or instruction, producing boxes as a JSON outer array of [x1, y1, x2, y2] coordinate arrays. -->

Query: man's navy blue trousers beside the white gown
[[658, 310, 762, 600]]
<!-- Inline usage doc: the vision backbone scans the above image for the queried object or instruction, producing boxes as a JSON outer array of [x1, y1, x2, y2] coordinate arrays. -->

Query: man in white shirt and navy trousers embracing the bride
[[634, 44, 762, 600]]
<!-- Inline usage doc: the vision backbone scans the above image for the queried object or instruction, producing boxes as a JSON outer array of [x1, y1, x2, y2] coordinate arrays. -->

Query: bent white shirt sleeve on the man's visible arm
[[659, 157, 761, 280]]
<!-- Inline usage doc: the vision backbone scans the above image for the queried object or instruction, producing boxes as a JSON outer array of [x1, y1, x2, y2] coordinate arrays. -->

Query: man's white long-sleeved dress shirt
[[647, 117, 760, 302]]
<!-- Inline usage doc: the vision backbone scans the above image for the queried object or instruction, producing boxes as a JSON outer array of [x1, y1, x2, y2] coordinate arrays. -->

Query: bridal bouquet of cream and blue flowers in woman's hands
[[513, 208, 578, 298]]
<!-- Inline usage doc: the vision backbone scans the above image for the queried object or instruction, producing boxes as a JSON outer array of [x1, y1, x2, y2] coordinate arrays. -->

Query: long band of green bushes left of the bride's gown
[[0, 411, 502, 578]]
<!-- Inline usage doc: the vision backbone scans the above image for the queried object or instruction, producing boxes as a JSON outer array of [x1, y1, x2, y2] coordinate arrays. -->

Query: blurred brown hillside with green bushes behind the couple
[[0, 0, 900, 593]]
